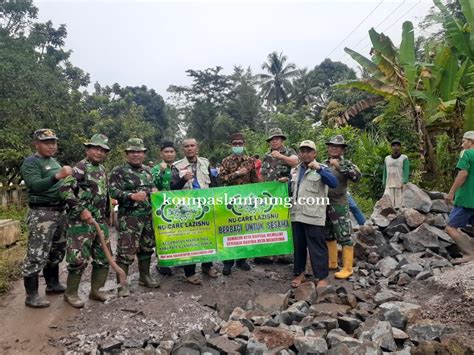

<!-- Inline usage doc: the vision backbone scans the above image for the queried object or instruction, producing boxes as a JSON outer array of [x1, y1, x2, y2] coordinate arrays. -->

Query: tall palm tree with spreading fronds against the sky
[[256, 52, 297, 108]]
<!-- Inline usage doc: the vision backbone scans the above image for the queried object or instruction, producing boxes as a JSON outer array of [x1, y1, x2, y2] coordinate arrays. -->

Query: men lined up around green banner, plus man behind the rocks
[[21, 128, 474, 308]]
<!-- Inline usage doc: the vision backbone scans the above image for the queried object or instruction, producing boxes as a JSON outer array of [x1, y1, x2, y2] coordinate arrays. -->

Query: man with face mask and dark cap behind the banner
[[219, 133, 258, 275]]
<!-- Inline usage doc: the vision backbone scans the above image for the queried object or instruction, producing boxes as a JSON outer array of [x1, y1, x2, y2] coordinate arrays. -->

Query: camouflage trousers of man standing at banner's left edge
[[117, 213, 155, 265]]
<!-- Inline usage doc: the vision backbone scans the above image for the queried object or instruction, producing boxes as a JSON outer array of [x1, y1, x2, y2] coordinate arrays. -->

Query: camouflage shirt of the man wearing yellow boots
[[326, 157, 362, 205]]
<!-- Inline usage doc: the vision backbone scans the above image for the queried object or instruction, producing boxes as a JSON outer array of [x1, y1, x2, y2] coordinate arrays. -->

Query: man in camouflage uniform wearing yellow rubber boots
[[326, 135, 362, 279]]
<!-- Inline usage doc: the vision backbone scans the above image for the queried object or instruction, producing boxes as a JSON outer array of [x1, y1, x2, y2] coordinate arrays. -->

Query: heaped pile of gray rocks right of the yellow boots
[[355, 184, 461, 288]]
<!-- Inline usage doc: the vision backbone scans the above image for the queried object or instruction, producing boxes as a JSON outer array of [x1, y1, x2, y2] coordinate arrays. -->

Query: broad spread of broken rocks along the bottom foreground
[[161, 282, 469, 355]]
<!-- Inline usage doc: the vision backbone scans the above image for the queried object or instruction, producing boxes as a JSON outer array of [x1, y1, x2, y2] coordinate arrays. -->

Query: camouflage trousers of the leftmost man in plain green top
[[22, 209, 66, 277]]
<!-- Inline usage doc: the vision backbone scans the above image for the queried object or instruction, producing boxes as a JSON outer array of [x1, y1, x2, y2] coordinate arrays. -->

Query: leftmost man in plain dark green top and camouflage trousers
[[20, 129, 72, 308]]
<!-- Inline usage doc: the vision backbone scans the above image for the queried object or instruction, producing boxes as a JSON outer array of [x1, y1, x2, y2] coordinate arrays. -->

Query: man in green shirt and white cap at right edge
[[446, 131, 474, 264]]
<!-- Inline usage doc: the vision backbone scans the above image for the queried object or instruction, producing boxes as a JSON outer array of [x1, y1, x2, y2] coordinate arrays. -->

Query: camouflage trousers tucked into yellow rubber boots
[[326, 203, 352, 246]]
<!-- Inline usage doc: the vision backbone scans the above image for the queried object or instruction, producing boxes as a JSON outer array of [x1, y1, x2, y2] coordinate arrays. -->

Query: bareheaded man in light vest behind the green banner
[[171, 138, 218, 285]]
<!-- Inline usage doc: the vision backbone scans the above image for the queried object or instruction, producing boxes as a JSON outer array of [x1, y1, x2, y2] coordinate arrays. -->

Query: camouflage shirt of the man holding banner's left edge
[[109, 163, 154, 214]]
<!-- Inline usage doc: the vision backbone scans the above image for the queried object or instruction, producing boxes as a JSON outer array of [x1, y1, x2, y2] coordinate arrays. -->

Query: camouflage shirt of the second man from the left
[[59, 159, 109, 223]]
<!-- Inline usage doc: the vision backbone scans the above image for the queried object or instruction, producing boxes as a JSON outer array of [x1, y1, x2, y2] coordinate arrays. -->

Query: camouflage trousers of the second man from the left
[[66, 221, 111, 274]]
